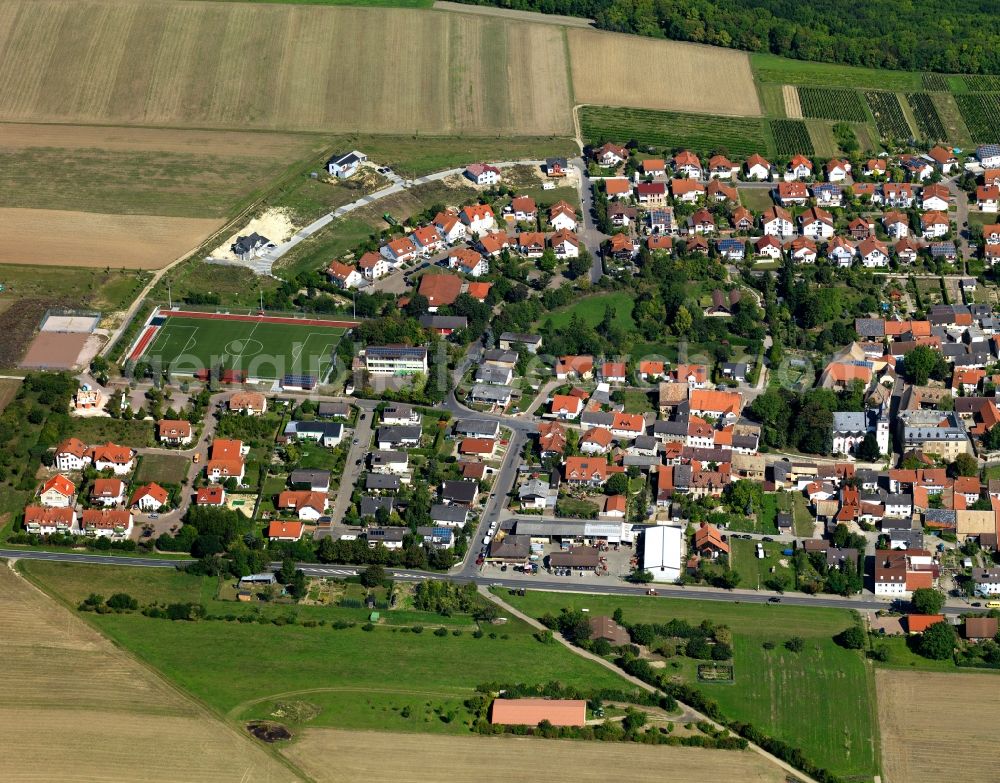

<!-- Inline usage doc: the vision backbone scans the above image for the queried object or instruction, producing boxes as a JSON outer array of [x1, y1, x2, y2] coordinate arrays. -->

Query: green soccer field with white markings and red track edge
[[142, 316, 346, 381]]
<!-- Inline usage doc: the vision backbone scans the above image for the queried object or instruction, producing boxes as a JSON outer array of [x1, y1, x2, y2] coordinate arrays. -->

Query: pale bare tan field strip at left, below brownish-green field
[[0, 208, 222, 269]]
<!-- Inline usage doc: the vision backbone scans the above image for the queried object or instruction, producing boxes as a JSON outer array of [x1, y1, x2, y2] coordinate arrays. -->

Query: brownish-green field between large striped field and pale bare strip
[[0, 124, 326, 218]]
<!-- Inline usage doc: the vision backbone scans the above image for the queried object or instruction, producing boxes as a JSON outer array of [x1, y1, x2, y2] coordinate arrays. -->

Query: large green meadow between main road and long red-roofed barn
[[24, 562, 624, 733]]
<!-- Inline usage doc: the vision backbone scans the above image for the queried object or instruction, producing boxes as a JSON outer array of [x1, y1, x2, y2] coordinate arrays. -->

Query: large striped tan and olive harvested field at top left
[[0, 0, 572, 135]]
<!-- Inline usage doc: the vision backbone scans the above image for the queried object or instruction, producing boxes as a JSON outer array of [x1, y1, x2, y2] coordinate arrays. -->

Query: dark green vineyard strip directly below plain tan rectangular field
[[579, 106, 767, 157]]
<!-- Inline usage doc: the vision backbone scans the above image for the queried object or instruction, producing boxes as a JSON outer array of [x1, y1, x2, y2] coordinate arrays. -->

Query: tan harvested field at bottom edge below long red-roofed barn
[[282, 729, 785, 783]]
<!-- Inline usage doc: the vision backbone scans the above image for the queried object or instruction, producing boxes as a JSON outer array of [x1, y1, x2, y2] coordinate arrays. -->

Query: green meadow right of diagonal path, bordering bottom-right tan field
[[502, 590, 879, 779]]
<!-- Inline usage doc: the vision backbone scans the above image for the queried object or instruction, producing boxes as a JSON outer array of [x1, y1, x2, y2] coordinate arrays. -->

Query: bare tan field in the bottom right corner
[[875, 671, 1000, 783]]
